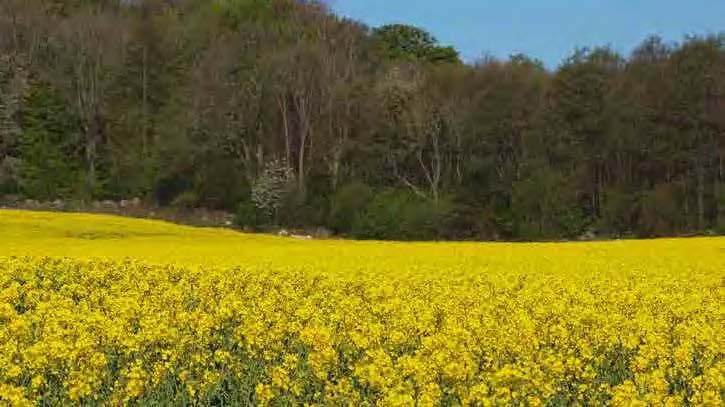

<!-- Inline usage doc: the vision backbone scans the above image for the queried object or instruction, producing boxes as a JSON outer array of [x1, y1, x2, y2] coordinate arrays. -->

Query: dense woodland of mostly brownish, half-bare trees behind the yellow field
[[0, 0, 725, 240]]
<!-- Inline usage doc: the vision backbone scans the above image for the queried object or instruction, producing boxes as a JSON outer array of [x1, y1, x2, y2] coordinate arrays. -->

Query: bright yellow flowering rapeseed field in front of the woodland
[[0, 211, 725, 406]]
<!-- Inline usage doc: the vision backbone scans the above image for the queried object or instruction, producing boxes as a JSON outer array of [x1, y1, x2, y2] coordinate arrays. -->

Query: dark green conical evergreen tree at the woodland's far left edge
[[19, 83, 80, 200]]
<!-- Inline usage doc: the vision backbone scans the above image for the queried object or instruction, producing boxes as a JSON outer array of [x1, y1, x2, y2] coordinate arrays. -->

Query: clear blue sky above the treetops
[[327, 0, 725, 67]]
